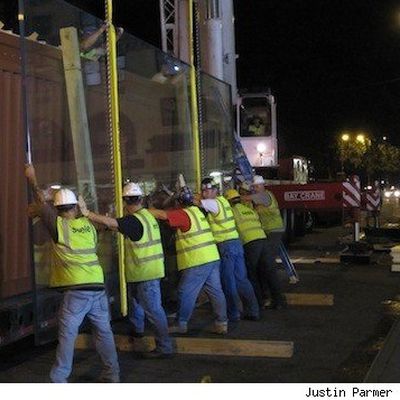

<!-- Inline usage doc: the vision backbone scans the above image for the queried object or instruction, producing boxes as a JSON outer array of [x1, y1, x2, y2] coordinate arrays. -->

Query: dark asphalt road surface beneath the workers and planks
[[0, 229, 400, 383]]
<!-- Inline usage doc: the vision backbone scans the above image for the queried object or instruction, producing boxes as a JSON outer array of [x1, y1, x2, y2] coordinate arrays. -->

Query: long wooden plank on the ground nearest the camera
[[75, 334, 294, 358]]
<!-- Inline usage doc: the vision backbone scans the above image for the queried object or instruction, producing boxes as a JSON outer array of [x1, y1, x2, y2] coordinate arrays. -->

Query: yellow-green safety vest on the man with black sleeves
[[125, 208, 164, 282]]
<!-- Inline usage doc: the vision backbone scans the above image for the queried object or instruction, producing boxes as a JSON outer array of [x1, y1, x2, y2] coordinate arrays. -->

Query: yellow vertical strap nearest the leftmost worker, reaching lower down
[[106, 0, 127, 316]]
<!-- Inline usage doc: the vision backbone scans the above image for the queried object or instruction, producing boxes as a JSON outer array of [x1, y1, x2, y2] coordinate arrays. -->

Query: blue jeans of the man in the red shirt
[[177, 261, 228, 327]]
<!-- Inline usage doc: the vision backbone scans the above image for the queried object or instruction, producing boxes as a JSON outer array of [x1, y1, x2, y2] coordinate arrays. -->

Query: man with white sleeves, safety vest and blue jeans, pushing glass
[[200, 178, 260, 322]]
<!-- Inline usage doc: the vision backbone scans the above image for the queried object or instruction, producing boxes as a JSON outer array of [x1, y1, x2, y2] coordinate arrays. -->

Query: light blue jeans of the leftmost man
[[50, 290, 119, 383]]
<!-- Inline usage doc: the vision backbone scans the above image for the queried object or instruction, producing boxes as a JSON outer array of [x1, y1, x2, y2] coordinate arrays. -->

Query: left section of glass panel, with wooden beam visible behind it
[[23, 0, 119, 343]]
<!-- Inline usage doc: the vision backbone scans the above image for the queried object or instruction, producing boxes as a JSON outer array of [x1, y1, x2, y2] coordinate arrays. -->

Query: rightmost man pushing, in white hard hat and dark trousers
[[250, 175, 285, 308]]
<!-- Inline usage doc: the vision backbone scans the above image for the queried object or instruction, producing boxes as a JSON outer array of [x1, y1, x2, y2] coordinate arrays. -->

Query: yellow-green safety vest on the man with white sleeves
[[207, 196, 239, 243]]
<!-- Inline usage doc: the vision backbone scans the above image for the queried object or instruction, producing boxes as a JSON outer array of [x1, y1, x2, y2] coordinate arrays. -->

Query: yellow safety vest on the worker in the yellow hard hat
[[232, 203, 266, 244]]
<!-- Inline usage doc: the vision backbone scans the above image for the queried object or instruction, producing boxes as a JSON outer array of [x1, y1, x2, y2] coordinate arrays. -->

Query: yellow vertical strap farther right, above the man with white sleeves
[[189, 0, 201, 192]]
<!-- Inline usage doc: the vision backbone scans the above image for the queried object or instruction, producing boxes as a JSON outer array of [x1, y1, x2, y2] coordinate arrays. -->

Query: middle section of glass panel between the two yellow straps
[[118, 33, 195, 308]]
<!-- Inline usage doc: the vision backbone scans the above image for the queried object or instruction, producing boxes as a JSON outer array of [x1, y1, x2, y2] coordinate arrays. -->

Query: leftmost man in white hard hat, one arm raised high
[[25, 165, 120, 383]]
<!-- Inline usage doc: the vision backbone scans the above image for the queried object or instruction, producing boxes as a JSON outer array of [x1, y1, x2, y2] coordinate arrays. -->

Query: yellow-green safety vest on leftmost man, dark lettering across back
[[50, 217, 104, 287]]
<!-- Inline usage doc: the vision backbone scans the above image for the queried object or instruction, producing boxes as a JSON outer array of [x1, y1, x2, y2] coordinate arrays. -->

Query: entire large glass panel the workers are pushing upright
[[24, 0, 238, 334]]
